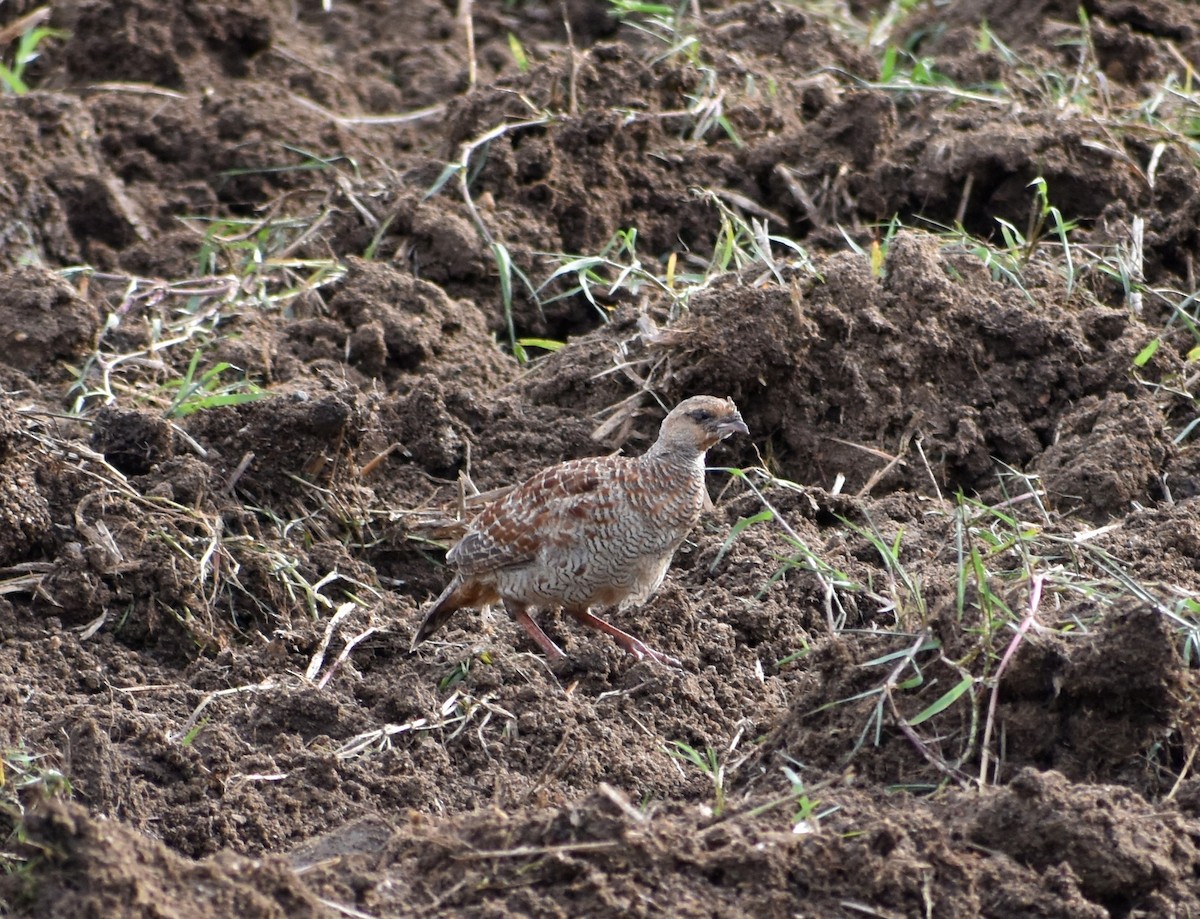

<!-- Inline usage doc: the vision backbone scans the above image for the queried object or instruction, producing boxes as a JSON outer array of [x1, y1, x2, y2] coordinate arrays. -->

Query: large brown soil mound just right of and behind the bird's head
[[600, 233, 1142, 503]]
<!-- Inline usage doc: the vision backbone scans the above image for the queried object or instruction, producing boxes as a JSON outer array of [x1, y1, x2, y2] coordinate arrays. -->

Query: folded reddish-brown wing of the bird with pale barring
[[446, 457, 629, 577]]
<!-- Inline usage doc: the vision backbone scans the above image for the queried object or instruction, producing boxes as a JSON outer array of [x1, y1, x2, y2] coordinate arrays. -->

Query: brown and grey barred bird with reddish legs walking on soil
[[409, 396, 750, 667]]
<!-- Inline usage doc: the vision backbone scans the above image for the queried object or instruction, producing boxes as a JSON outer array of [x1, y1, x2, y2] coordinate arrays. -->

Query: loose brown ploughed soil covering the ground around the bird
[[0, 0, 1200, 919]]
